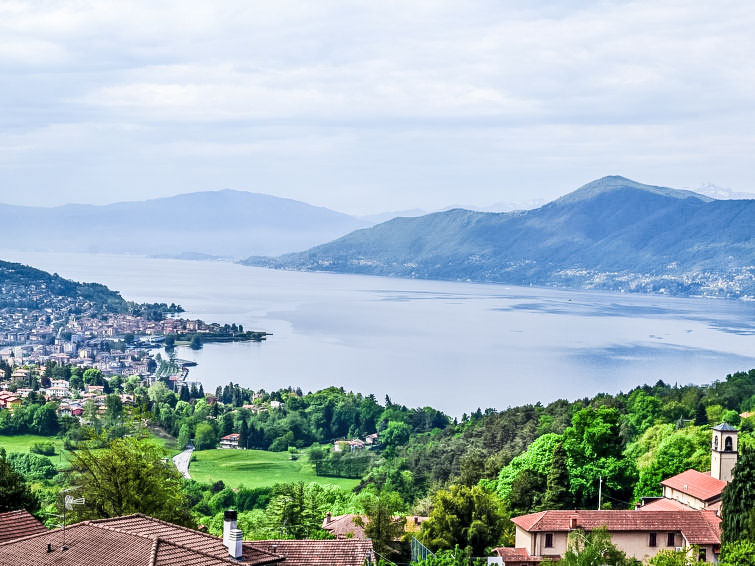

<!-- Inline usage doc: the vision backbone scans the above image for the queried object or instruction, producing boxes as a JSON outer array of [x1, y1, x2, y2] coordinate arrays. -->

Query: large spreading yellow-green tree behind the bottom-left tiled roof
[[70, 438, 194, 526]]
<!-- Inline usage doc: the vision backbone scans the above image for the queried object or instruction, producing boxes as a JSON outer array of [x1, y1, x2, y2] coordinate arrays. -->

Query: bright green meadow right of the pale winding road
[[189, 449, 359, 489]]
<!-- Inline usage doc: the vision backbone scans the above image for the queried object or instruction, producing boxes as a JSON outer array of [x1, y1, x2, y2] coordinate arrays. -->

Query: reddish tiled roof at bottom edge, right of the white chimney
[[250, 539, 375, 566]]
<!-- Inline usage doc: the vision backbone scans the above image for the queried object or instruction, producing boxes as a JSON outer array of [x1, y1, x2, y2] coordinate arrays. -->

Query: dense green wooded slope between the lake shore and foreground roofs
[[0, 364, 755, 555]]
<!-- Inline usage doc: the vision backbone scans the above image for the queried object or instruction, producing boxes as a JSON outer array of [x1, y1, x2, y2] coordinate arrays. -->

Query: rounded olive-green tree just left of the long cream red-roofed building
[[420, 485, 506, 556]]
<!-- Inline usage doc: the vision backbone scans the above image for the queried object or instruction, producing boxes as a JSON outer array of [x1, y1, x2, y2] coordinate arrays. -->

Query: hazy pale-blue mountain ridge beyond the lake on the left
[[0, 190, 371, 259]]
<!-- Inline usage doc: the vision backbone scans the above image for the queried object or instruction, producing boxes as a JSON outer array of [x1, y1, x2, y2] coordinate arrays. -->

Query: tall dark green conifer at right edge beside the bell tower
[[721, 445, 755, 543]]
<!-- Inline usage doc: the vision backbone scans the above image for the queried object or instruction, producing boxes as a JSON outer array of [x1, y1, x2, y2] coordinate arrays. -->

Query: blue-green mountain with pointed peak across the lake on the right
[[243, 176, 755, 297]]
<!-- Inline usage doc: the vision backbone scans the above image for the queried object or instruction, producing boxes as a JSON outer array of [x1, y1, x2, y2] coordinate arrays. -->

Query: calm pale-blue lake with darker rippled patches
[[0, 251, 755, 416]]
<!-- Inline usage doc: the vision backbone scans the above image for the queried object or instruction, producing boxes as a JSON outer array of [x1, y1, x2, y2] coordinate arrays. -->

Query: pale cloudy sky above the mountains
[[0, 0, 755, 214]]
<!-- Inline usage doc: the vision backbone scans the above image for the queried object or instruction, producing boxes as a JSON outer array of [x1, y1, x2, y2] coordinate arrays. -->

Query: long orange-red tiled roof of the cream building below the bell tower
[[511, 510, 721, 544]]
